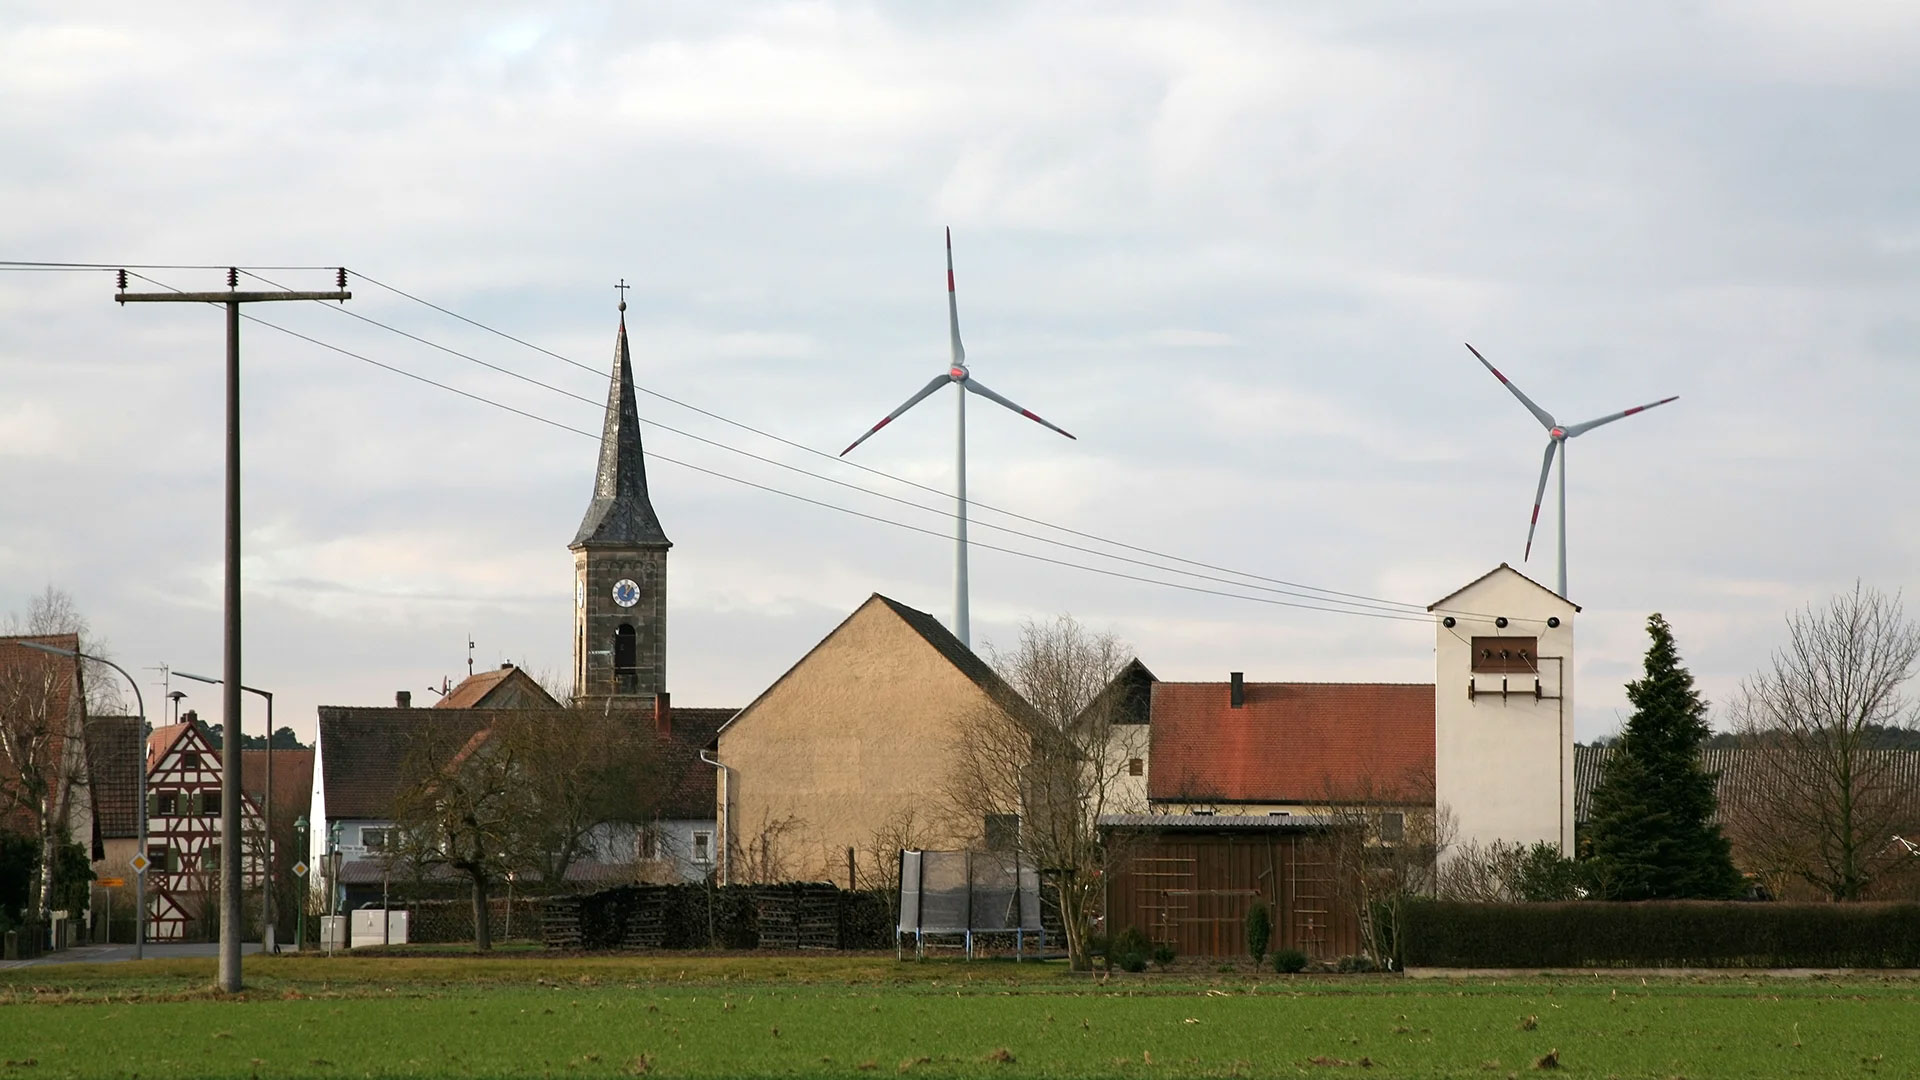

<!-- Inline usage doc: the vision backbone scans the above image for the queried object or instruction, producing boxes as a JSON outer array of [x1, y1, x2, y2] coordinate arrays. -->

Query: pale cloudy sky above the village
[[0, 0, 1920, 740]]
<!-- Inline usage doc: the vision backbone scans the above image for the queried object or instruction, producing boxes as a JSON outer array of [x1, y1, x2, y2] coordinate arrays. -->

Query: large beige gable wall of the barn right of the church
[[718, 598, 991, 884]]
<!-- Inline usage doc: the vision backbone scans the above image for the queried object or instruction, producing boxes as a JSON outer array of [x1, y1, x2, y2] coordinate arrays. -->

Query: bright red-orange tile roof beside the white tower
[[1146, 682, 1434, 803]]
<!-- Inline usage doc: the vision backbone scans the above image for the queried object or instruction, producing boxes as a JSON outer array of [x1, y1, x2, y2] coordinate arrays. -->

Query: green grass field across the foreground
[[0, 955, 1920, 1080]]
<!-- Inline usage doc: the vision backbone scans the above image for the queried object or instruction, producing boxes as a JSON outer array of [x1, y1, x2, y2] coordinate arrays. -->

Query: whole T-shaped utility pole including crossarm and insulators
[[113, 267, 353, 994]]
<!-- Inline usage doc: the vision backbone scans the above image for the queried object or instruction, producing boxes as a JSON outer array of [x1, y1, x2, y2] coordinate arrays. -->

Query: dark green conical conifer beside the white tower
[[1584, 613, 1741, 899]]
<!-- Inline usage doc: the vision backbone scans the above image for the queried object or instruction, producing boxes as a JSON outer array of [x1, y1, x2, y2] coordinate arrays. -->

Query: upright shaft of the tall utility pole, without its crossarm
[[219, 300, 242, 994]]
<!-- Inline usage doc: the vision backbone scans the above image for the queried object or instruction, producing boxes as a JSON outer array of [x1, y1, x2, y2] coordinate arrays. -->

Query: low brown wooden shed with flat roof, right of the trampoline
[[1100, 815, 1359, 961]]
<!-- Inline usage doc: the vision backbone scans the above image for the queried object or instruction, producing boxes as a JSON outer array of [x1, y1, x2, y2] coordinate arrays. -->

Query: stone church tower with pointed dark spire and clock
[[568, 300, 672, 707]]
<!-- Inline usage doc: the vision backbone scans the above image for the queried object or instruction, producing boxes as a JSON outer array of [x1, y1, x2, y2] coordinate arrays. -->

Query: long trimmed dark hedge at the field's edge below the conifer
[[1402, 901, 1920, 969]]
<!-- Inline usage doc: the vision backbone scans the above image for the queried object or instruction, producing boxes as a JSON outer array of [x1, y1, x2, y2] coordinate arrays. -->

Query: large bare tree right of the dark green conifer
[[1724, 584, 1920, 899]]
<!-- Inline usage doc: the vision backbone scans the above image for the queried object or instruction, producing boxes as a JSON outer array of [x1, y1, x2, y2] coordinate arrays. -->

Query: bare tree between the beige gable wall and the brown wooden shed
[[945, 615, 1146, 969]]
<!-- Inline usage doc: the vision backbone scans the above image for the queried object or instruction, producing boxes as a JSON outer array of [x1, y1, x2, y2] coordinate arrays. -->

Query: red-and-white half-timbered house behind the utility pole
[[146, 713, 265, 942]]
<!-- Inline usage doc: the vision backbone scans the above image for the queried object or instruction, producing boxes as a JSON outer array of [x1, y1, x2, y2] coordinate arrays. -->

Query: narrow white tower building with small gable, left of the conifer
[[1434, 569, 1578, 853]]
